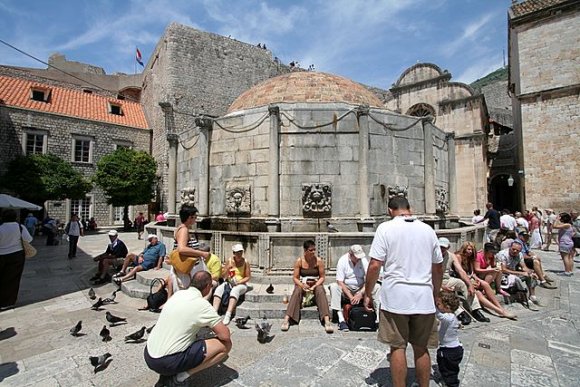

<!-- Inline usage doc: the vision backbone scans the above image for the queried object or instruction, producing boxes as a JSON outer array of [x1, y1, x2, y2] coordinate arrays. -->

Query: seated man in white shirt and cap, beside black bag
[[330, 245, 381, 331]]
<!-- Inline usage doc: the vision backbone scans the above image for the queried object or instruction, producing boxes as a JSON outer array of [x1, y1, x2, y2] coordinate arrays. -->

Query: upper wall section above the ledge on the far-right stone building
[[516, 7, 580, 94]]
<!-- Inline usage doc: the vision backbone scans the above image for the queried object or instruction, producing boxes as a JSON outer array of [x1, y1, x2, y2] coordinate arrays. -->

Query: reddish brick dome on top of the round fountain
[[228, 71, 383, 113]]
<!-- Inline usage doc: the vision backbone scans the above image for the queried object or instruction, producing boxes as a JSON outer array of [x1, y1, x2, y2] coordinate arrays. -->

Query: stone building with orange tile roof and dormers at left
[[0, 74, 150, 225]]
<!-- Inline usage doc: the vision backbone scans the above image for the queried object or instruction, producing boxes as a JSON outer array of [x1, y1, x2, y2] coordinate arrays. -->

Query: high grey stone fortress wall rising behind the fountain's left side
[[142, 23, 289, 210]]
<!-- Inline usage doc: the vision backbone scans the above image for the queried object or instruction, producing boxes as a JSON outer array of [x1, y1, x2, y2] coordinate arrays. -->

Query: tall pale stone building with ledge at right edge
[[508, 0, 580, 211]]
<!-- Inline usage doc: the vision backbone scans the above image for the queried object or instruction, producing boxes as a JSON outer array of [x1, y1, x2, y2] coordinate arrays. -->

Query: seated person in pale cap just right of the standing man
[[439, 238, 490, 325]]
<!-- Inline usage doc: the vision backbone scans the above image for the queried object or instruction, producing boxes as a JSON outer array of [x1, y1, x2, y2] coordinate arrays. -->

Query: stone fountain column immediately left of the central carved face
[[268, 105, 280, 228]]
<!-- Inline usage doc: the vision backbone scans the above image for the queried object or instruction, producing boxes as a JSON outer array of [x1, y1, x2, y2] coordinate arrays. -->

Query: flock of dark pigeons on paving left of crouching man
[[70, 288, 155, 373]]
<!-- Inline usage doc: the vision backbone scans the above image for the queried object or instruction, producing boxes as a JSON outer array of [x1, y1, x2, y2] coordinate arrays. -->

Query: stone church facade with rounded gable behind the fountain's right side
[[385, 63, 489, 217]]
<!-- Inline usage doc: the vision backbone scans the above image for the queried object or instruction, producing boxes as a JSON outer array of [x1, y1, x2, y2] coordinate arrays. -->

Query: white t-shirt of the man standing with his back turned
[[369, 216, 443, 314]]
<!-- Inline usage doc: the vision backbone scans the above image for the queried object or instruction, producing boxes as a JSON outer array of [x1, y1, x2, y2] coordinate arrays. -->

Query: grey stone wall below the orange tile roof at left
[[0, 106, 149, 226]]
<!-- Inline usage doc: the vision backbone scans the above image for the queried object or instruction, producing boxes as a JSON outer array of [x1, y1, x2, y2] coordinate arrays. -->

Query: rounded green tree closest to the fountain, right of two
[[94, 148, 157, 228]]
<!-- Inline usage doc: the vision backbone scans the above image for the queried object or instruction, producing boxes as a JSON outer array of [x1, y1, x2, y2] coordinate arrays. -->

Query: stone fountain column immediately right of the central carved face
[[356, 105, 370, 220]]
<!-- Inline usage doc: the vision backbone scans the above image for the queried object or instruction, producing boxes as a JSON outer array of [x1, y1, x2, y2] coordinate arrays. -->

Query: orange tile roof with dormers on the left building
[[0, 76, 149, 129]]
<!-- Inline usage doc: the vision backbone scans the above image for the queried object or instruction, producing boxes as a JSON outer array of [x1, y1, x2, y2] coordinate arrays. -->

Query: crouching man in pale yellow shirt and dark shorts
[[144, 271, 232, 386]]
